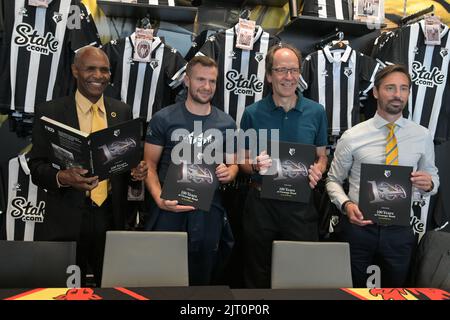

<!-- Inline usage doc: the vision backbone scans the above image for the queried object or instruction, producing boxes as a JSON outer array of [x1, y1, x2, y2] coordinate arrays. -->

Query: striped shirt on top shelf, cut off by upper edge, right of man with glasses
[[302, 0, 353, 20]]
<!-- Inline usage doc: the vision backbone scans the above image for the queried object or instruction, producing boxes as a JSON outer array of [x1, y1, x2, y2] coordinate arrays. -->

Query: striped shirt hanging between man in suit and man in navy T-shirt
[[104, 33, 186, 122]]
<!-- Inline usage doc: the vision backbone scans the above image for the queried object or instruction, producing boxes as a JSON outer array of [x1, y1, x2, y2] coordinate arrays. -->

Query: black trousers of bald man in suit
[[77, 197, 113, 287]]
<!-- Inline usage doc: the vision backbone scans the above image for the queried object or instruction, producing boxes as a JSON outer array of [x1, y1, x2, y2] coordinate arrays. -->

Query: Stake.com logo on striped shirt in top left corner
[[14, 23, 59, 55]]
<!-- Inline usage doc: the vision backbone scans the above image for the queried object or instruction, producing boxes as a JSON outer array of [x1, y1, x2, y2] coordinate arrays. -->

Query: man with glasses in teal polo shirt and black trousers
[[240, 44, 327, 288]]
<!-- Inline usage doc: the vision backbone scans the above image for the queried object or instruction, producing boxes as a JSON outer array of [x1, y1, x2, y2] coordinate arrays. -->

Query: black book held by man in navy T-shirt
[[161, 161, 219, 211]]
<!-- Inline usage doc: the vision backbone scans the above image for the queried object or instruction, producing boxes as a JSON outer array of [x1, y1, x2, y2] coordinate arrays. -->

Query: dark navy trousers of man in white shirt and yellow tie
[[341, 217, 417, 288]]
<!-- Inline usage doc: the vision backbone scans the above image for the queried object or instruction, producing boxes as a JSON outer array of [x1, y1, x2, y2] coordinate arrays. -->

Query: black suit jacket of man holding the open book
[[29, 95, 132, 241]]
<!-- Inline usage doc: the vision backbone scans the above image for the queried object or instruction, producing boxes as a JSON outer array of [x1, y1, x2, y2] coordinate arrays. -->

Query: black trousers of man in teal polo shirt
[[243, 187, 319, 288]]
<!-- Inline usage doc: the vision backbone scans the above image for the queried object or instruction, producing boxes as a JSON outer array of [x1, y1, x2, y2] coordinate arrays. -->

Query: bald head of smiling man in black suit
[[72, 47, 111, 103]]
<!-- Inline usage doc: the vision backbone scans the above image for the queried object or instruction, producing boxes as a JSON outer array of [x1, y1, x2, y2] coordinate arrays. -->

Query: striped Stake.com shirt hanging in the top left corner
[[0, 0, 100, 113]]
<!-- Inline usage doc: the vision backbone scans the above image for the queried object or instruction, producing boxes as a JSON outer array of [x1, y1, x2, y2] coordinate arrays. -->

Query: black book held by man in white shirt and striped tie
[[359, 163, 413, 226]]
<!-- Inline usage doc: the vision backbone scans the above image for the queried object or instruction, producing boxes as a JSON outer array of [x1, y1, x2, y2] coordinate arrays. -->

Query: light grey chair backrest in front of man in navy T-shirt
[[102, 231, 189, 287]]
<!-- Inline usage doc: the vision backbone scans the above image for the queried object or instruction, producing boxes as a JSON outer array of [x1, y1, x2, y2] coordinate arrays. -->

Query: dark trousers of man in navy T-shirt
[[147, 204, 229, 286]]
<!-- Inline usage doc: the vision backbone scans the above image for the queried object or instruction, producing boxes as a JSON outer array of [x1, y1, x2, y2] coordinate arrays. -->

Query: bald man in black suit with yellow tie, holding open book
[[29, 47, 147, 285]]
